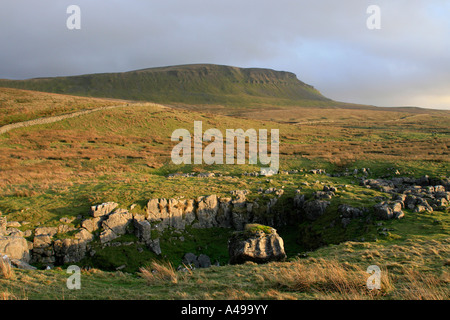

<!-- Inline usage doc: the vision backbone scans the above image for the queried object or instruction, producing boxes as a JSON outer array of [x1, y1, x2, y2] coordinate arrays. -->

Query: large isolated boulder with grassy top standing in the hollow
[[228, 224, 286, 264]]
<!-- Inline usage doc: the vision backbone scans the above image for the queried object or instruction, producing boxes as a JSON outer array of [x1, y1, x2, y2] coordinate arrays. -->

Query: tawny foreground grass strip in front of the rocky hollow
[[0, 239, 450, 300]]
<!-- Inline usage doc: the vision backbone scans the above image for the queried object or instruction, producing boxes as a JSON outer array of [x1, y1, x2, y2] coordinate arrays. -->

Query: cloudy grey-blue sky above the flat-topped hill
[[0, 0, 450, 110]]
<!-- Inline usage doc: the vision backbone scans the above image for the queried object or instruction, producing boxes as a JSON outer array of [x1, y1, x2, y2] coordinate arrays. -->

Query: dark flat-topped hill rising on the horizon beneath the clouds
[[0, 64, 331, 106]]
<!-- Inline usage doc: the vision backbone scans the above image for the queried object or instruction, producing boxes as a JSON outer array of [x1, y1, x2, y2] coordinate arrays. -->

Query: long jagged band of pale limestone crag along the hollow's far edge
[[0, 171, 450, 268]]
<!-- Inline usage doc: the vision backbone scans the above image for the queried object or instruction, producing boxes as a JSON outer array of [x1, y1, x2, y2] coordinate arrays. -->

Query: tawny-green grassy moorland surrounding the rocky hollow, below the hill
[[0, 70, 450, 299]]
